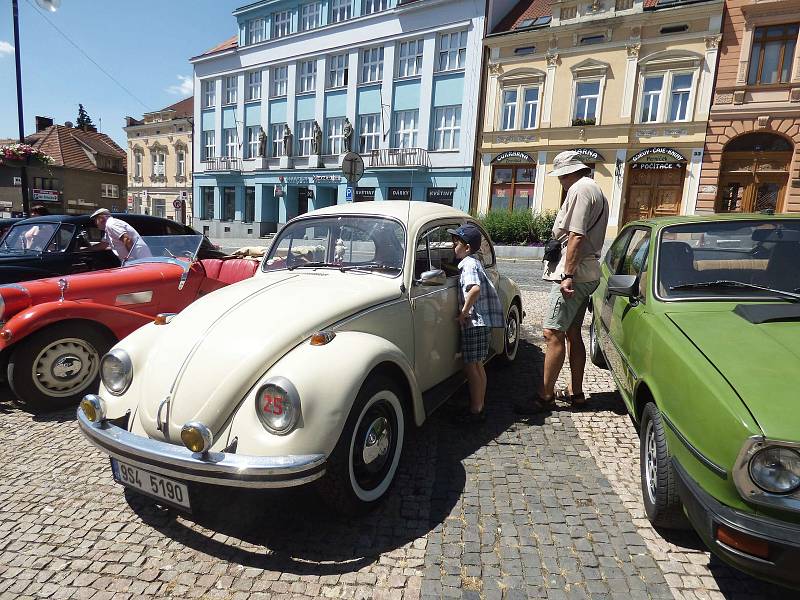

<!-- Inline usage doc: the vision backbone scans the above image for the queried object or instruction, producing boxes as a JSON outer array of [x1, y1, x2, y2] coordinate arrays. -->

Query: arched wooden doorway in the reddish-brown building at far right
[[716, 133, 794, 212]]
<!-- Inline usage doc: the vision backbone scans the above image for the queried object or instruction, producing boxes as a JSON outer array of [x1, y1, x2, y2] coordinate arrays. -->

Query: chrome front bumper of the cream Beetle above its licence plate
[[78, 408, 325, 488]]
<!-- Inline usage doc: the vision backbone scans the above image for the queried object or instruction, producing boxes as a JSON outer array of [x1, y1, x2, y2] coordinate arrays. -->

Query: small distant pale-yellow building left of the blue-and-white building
[[125, 98, 194, 225]]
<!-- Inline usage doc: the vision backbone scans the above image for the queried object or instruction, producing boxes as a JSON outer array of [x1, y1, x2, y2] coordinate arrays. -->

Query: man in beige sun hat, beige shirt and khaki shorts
[[515, 150, 608, 414]]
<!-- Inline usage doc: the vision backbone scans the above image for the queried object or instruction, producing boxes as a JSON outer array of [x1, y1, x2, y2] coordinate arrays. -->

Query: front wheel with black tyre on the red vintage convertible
[[8, 323, 115, 411]]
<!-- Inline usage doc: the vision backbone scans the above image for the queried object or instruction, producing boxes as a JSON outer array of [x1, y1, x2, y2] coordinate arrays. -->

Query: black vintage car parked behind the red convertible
[[0, 213, 225, 284]]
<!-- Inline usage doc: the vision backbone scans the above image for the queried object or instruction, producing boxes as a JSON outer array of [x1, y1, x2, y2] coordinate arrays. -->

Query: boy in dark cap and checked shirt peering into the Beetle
[[454, 225, 505, 423]]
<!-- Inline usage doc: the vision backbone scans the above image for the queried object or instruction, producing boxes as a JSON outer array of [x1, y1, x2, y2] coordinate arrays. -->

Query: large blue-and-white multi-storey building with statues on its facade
[[191, 0, 484, 237]]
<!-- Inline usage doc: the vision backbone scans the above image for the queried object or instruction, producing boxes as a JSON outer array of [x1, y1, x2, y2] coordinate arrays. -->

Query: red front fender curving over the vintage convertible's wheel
[[0, 300, 153, 350]]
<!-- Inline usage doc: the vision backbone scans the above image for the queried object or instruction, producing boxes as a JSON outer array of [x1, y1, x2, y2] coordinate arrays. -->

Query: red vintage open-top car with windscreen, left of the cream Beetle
[[0, 235, 258, 411]]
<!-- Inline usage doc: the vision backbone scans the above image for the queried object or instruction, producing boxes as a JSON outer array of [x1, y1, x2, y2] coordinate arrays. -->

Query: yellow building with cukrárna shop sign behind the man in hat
[[474, 0, 723, 235]]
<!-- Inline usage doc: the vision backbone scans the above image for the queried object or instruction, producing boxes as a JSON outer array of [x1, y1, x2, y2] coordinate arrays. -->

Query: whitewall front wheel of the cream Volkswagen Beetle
[[320, 376, 406, 515]]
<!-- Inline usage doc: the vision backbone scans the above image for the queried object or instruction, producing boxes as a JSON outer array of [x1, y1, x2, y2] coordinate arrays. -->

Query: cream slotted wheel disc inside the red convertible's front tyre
[[31, 338, 99, 397]]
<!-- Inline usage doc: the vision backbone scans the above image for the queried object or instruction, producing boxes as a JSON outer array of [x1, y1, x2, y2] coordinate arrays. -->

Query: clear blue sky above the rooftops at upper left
[[0, 0, 241, 147]]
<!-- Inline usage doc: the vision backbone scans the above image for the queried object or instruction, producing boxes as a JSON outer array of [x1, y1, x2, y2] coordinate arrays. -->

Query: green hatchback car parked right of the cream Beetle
[[590, 215, 800, 587]]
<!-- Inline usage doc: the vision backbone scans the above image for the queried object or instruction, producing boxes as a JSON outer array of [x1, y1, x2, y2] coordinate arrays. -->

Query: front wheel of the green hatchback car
[[639, 402, 686, 529]]
